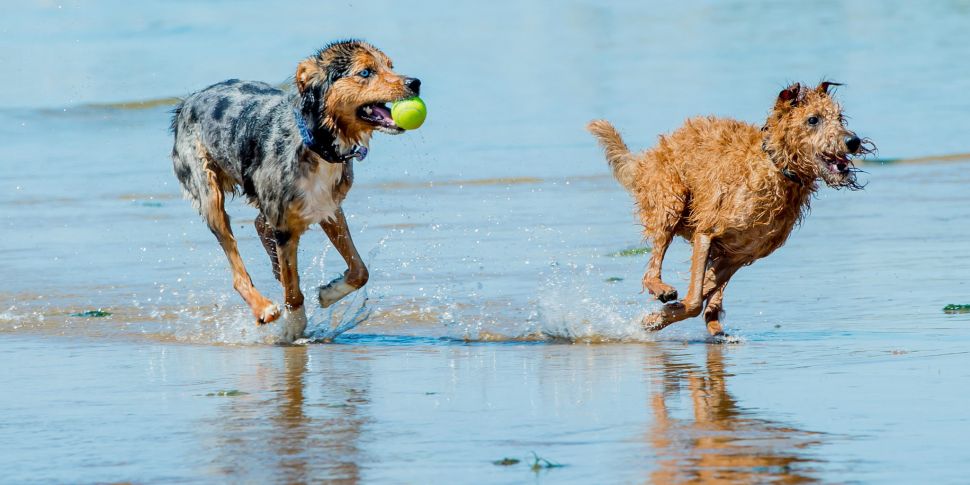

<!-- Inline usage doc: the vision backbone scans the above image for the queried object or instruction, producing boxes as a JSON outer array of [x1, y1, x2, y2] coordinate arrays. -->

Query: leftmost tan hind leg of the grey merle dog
[[200, 161, 280, 324]]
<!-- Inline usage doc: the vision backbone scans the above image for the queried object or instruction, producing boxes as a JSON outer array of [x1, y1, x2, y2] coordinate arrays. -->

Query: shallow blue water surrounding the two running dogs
[[0, 1, 970, 483]]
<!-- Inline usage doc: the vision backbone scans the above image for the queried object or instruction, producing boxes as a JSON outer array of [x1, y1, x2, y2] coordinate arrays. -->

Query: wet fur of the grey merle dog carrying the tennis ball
[[172, 40, 419, 323]]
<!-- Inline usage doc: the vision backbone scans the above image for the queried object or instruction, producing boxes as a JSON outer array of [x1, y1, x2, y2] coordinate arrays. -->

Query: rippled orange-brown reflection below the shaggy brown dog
[[647, 345, 820, 483]]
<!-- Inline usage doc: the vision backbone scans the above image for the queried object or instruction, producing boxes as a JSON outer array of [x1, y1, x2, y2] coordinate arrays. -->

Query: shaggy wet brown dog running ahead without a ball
[[588, 82, 873, 335]]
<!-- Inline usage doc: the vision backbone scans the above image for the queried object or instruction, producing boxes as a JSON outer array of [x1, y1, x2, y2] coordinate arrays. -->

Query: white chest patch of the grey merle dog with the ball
[[296, 162, 350, 225]]
